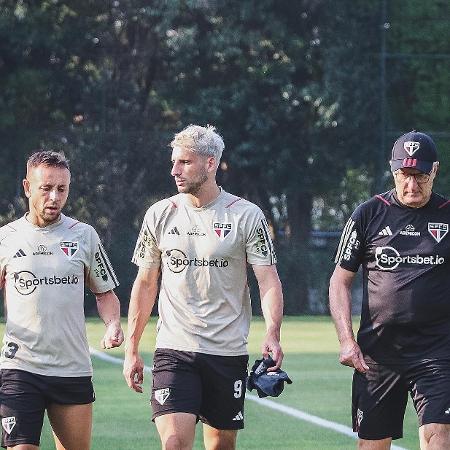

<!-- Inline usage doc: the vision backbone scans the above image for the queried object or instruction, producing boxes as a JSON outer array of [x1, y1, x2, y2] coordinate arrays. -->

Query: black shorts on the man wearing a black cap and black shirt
[[352, 360, 450, 440]]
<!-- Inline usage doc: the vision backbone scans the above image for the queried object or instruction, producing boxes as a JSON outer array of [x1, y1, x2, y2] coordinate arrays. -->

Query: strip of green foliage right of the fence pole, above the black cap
[[386, 0, 450, 182]]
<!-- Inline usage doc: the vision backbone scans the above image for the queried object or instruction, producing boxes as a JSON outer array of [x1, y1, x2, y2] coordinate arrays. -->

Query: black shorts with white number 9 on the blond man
[[151, 349, 248, 430]]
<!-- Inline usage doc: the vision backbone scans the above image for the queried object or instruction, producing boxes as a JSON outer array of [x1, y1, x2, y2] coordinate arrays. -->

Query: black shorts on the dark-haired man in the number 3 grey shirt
[[0, 369, 95, 448]]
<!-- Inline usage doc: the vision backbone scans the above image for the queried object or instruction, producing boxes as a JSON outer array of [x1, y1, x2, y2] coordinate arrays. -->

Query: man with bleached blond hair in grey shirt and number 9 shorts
[[124, 125, 283, 450]]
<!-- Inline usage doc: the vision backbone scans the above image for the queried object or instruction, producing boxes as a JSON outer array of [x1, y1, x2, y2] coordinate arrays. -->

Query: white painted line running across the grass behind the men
[[89, 347, 407, 450]]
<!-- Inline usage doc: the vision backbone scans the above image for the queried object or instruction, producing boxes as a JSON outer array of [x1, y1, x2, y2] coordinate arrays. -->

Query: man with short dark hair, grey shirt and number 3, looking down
[[0, 151, 123, 450]]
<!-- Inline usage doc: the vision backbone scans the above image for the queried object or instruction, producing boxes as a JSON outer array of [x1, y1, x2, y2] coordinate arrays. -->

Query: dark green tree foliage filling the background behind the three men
[[0, 0, 450, 312]]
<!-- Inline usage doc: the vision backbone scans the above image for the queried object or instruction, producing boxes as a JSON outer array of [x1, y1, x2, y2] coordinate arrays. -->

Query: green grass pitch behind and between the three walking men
[[2, 317, 419, 450]]
